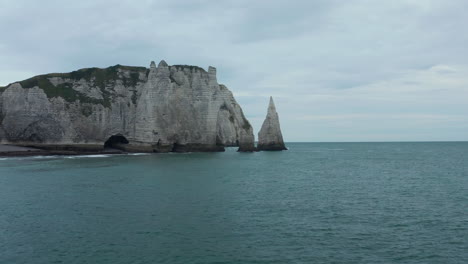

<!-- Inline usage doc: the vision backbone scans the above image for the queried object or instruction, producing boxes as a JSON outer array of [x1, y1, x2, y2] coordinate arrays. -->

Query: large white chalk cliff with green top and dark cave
[[0, 61, 254, 152]]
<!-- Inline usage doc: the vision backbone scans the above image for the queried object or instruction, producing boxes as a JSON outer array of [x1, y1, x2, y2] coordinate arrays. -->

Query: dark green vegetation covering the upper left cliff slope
[[17, 65, 147, 107]]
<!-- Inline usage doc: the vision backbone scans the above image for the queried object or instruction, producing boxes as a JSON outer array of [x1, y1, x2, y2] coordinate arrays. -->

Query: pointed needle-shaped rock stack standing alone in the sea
[[257, 97, 287, 150]]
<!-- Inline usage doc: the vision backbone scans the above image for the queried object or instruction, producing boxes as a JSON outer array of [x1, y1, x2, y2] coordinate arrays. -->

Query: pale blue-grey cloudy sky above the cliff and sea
[[0, 0, 468, 141]]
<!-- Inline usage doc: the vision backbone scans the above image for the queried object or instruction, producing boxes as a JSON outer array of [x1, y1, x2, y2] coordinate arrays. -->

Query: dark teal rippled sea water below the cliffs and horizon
[[0, 142, 468, 264]]
